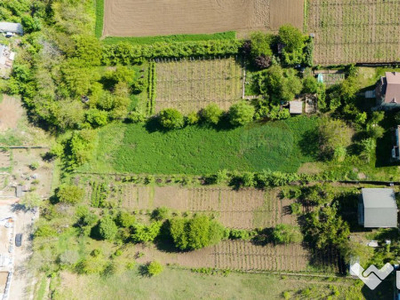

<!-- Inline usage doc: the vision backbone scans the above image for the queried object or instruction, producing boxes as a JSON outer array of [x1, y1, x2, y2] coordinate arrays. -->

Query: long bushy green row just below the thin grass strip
[[102, 39, 242, 65]]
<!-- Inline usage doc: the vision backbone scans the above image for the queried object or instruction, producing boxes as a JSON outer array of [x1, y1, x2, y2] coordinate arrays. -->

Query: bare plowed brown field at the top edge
[[103, 0, 304, 37]]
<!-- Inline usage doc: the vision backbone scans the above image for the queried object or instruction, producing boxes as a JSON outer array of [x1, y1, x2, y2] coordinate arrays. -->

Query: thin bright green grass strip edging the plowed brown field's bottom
[[98, 31, 236, 45]]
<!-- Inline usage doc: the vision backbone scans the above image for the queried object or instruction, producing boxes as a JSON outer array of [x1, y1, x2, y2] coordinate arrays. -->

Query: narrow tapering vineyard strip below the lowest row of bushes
[[134, 240, 339, 274]]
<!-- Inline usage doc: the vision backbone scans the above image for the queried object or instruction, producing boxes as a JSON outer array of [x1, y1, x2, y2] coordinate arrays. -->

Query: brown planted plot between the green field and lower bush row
[[116, 184, 295, 229]]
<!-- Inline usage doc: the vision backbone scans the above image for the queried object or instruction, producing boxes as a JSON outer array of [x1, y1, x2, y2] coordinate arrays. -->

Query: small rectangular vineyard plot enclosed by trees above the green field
[[155, 57, 242, 114]]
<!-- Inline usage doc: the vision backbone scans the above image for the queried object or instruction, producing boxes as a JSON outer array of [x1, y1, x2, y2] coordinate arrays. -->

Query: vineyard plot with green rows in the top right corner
[[307, 0, 400, 65]]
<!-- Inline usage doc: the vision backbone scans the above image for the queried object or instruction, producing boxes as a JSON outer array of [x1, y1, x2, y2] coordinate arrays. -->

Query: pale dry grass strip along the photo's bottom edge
[[54, 268, 363, 300]]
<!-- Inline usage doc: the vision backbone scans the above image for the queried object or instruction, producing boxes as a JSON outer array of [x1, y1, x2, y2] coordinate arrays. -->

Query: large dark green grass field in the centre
[[79, 117, 317, 174]]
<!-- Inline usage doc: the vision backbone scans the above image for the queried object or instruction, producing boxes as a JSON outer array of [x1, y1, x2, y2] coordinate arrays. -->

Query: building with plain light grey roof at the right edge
[[358, 188, 397, 228]]
